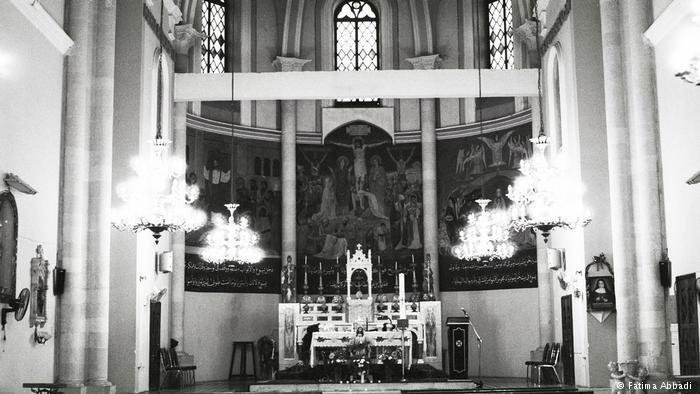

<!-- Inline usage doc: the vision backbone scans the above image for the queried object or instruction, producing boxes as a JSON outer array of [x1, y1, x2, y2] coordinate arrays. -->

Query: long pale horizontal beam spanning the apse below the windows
[[174, 69, 537, 101]]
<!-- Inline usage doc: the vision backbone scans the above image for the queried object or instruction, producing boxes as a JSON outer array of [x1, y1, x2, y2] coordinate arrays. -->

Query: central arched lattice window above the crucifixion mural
[[335, 0, 379, 105]]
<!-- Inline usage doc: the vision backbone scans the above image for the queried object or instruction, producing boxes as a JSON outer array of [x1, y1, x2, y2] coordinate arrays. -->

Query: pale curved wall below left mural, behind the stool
[[184, 292, 279, 382]]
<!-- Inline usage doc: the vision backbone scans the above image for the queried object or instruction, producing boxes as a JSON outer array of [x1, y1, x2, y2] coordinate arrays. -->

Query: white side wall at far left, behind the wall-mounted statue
[[0, 1, 63, 393]]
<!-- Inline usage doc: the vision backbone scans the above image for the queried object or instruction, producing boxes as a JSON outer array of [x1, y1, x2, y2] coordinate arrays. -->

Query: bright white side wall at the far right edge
[[655, 10, 700, 286]]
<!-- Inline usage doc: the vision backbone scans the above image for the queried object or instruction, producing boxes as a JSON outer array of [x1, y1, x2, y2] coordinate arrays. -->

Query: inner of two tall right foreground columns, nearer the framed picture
[[600, 0, 638, 361]]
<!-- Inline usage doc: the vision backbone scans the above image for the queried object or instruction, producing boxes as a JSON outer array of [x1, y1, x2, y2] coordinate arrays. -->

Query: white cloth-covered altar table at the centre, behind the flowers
[[309, 331, 413, 367]]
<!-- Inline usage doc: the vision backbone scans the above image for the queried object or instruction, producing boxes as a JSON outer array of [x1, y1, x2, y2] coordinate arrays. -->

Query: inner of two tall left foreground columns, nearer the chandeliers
[[86, 1, 116, 393]]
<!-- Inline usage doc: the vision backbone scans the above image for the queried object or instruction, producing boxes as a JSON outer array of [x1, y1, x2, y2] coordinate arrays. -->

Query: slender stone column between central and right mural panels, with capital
[[406, 55, 441, 297]]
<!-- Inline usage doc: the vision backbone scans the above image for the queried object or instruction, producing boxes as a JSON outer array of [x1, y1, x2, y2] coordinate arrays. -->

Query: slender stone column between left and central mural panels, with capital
[[273, 56, 310, 302]]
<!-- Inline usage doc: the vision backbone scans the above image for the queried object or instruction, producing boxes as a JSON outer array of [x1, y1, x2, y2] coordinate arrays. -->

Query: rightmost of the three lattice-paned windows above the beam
[[488, 0, 513, 70]]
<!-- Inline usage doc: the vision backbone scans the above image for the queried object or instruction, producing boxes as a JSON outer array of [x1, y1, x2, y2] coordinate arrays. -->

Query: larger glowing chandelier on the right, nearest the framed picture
[[507, 131, 591, 242]]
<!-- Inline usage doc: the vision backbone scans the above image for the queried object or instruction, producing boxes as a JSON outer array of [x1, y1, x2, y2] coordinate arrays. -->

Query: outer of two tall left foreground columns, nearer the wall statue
[[55, 1, 96, 392]]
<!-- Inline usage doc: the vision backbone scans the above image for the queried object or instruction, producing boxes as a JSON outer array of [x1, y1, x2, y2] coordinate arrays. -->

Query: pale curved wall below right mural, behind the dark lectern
[[440, 288, 540, 377]]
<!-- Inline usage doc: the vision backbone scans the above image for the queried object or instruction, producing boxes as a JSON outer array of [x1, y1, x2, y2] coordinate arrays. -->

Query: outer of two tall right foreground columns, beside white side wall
[[620, 0, 668, 379]]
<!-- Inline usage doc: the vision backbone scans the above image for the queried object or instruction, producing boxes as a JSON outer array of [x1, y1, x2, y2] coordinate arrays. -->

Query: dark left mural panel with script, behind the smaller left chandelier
[[185, 130, 282, 293]]
